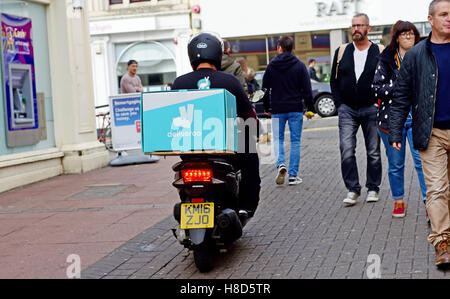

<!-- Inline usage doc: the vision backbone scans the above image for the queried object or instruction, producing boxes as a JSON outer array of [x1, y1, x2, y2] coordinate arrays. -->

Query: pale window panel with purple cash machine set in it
[[0, 1, 55, 155]]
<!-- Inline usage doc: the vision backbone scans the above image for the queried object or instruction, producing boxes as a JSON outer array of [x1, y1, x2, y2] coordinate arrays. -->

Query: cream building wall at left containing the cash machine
[[0, 0, 109, 192]]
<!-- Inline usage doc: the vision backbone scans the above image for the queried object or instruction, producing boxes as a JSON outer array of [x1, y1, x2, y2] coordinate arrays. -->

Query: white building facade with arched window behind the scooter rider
[[88, 0, 192, 106]]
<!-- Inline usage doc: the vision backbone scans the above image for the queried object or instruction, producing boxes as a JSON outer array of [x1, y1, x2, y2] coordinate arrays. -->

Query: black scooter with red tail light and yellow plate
[[172, 155, 248, 272]]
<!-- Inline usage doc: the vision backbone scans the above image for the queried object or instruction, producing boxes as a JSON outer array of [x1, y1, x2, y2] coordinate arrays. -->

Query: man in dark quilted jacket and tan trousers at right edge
[[389, 0, 450, 267]]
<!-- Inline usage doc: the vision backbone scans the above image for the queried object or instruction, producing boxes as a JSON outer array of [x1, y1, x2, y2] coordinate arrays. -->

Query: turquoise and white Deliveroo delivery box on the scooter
[[141, 89, 237, 155]]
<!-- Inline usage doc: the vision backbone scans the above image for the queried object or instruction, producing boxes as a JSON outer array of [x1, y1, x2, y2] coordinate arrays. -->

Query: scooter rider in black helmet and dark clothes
[[172, 33, 261, 217]]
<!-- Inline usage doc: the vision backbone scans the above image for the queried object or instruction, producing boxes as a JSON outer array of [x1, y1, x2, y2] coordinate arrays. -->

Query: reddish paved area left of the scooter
[[0, 154, 178, 278]]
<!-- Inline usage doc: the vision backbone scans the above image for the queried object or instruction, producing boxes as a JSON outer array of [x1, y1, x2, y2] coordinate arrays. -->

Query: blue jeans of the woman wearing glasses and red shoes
[[378, 122, 427, 200]]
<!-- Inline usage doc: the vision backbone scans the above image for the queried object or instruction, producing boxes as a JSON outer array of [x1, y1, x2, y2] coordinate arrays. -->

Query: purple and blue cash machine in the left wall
[[0, 14, 41, 147]]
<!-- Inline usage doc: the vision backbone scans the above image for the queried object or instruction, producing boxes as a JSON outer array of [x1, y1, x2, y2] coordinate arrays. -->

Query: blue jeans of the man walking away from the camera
[[272, 112, 303, 177]]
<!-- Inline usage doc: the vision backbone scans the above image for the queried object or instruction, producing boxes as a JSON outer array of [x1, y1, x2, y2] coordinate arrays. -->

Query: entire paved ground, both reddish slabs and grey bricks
[[0, 118, 450, 279]]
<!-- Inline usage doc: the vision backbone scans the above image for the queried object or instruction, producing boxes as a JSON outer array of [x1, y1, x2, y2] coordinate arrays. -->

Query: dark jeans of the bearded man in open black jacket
[[339, 104, 382, 194]]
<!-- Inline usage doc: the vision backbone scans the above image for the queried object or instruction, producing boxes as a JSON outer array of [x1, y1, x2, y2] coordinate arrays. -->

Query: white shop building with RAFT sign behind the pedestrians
[[198, 0, 431, 81]]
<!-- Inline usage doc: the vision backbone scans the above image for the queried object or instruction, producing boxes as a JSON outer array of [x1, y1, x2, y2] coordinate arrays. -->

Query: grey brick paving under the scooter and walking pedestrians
[[82, 118, 450, 279]]
